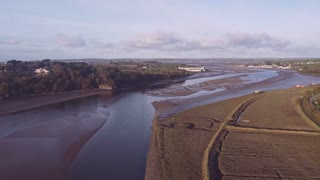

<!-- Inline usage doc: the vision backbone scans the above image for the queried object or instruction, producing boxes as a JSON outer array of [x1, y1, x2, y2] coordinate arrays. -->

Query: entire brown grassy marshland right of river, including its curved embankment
[[146, 88, 320, 179]]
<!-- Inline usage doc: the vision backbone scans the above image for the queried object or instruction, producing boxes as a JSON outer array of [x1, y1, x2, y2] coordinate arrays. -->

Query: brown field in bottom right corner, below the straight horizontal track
[[219, 130, 320, 179]]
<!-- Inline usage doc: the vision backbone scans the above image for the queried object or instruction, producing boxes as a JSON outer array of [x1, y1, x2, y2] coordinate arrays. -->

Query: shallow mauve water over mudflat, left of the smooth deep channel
[[0, 96, 108, 179]]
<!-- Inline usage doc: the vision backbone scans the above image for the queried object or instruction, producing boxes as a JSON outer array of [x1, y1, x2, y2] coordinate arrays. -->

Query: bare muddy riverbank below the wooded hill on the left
[[0, 90, 111, 117]]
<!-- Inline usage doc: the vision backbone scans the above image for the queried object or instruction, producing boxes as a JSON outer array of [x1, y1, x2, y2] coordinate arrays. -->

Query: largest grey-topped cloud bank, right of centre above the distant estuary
[[126, 32, 291, 51]]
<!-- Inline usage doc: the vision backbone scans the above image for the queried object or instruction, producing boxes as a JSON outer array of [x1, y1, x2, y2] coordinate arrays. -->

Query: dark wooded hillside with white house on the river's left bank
[[0, 59, 186, 97]]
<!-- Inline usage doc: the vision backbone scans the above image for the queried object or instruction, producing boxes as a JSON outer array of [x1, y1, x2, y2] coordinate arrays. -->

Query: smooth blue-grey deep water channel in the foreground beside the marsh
[[71, 92, 154, 179]]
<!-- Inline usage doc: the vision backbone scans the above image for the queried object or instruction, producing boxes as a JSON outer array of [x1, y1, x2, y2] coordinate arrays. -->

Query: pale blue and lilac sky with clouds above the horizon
[[0, 0, 320, 61]]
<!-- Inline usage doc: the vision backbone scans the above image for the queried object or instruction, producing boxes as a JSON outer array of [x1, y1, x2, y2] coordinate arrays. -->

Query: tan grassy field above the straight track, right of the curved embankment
[[237, 88, 318, 131]]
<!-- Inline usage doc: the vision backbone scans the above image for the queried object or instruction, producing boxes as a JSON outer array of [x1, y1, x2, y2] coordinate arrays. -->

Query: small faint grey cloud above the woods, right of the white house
[[56, 34, 87, 48]]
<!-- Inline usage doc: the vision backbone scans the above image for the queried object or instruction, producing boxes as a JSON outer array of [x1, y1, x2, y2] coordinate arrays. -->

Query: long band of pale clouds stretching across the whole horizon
[[0, 32, 320, 59]]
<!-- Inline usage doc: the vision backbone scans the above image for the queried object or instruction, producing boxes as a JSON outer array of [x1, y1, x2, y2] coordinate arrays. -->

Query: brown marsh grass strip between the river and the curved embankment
[[150, 95, 255, 179]]
